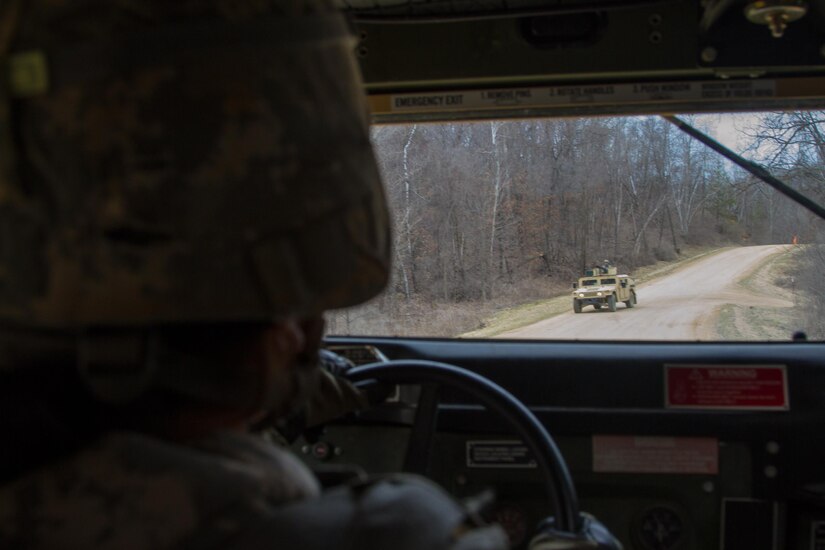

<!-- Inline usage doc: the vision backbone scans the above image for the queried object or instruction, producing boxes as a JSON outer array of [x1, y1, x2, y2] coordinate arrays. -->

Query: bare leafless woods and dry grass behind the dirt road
[[328, 111, 825, 339]]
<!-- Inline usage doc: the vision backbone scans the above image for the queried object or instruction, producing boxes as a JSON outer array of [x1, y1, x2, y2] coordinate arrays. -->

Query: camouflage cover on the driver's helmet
[[0, 0, 389, 328]]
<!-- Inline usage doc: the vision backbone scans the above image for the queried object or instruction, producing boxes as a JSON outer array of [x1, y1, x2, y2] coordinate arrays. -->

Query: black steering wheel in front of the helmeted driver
[[346, 359, 582, 533]]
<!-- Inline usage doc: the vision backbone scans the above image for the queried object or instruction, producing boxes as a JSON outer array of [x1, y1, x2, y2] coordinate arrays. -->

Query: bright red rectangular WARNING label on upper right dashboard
[[665, 365, 789, 411]]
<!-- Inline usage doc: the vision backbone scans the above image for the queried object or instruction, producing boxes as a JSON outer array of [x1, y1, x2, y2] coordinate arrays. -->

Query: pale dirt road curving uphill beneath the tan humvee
[[498, 245, 792, 340]]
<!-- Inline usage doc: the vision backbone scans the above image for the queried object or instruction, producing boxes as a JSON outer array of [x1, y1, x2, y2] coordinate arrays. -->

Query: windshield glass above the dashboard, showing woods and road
[[328, 112, 825, 341]]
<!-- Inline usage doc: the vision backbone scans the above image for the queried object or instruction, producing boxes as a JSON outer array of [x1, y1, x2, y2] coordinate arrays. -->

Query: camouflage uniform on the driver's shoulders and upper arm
[[0, 433, 507, 550]]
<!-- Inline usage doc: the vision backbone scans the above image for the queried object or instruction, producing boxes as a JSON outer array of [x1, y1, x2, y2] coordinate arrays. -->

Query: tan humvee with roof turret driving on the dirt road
[[573, 262, 636, 313]]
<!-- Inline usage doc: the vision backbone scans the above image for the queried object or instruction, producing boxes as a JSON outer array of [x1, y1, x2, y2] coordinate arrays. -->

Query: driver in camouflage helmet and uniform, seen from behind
[[0, 0, 506, 549]]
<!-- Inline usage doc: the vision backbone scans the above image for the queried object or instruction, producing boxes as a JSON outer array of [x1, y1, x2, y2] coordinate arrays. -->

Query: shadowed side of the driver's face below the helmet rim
[[249, 315, 324, 418]]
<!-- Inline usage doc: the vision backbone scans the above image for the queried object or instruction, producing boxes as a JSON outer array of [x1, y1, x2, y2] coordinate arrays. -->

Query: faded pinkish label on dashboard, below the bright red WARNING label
[[593, 435, 719, 475]]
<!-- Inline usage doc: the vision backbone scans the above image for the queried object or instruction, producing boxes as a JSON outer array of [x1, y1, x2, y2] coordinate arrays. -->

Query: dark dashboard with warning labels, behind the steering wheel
[[296, 337, 825, 550]]
